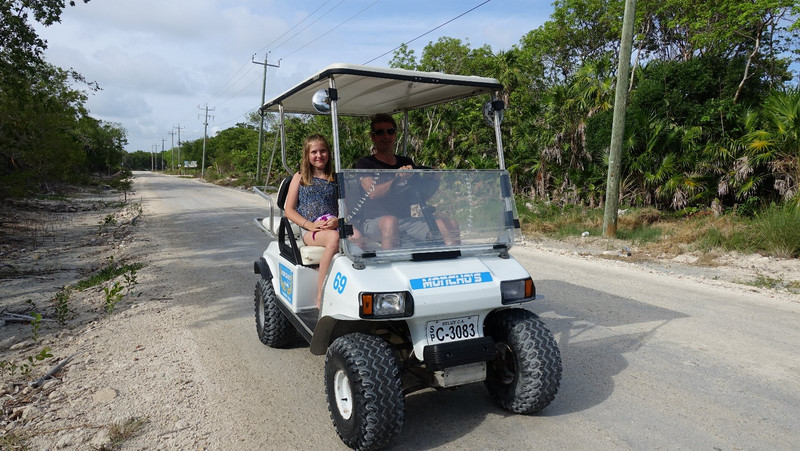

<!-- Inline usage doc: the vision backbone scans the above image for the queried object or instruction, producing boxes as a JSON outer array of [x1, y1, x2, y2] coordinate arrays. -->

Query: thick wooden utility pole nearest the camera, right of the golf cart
[[603, 0, 636, 238]]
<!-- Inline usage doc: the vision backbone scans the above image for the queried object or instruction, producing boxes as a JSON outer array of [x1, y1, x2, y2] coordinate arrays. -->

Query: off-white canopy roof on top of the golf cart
[[261, 64, 503, 116]]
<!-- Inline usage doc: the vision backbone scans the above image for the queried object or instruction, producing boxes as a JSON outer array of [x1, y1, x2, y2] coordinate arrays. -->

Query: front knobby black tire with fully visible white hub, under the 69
[[325, 333, 405, 450]]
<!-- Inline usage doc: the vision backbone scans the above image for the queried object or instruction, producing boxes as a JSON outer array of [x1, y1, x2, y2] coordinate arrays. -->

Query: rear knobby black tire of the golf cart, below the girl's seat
[[255, 279, 295, 348]]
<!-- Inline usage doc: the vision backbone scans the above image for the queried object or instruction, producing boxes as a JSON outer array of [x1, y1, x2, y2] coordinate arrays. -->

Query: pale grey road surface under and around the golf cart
[[136, 173, 800, 450]]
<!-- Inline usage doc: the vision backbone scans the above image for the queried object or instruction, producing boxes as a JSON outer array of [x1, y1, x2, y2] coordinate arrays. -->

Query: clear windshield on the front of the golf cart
[[339, 169, 516, 264]]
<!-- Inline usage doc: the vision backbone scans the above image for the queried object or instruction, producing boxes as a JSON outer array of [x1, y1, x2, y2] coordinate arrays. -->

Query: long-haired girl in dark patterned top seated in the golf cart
[[284, 134, 339, 308]]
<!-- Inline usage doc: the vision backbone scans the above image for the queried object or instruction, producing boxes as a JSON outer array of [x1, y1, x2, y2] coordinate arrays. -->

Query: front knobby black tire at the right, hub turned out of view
[[484, 309, 561, 414]]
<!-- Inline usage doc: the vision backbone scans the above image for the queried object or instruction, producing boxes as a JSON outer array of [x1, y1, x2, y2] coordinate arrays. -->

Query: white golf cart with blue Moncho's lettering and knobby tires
[[254, 64, 561, 449]]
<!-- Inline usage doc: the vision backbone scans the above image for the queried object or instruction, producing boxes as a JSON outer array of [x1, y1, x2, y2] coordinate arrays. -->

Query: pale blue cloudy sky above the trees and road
[[32, 0, 553, 152]]
